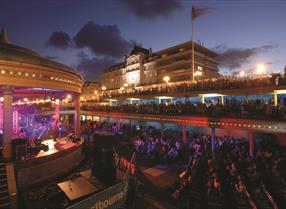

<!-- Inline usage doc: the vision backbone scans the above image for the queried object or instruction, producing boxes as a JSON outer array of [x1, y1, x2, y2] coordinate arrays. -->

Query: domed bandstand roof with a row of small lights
[[0, 28, 83, 93]]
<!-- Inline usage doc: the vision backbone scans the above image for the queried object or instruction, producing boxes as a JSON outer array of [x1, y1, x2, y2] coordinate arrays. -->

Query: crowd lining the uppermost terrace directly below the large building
[[103, 75, 286, 97]]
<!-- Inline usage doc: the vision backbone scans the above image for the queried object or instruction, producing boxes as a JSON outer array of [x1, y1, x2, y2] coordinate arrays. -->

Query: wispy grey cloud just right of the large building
[[215, 44, 277, 70]]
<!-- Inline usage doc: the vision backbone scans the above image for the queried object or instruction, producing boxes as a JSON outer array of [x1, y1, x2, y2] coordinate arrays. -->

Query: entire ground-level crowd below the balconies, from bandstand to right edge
[[20, 118, 286, 209]]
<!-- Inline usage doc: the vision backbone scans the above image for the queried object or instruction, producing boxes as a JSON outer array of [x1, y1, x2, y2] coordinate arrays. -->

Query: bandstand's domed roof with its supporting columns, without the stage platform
[[0, 29, 83, 160]]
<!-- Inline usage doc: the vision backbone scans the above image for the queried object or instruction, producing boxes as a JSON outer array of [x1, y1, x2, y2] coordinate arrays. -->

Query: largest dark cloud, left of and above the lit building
[[74, 21, 132, 58]]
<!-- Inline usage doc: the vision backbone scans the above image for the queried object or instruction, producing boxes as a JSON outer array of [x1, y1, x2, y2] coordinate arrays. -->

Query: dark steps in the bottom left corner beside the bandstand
[[0, 162, 11, 209]]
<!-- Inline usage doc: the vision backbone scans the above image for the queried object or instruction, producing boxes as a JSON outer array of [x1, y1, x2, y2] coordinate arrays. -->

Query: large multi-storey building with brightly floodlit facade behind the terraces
[[101, 41, 219, 90]]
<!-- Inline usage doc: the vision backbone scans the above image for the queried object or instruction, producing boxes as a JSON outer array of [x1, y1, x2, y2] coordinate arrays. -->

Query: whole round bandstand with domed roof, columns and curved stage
[[0, 29, 83, 208]]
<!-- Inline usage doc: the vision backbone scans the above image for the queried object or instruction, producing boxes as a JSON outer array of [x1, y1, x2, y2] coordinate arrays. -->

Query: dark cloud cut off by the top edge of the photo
[[119, 0, 182, 19]]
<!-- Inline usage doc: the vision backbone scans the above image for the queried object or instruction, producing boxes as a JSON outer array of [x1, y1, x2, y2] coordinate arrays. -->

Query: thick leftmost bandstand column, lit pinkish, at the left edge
[[2, 86, 13, 160]]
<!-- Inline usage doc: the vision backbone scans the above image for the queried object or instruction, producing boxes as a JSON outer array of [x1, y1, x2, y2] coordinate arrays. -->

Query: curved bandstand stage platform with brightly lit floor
[[15, 138, 83, 190]]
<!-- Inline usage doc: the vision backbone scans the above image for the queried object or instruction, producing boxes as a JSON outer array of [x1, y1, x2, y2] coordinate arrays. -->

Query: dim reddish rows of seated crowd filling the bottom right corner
[[171, 133, 286, 209]]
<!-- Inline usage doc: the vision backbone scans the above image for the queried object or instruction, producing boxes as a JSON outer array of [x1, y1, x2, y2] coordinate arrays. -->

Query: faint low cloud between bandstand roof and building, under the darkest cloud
[[76, 52, 117, 81]]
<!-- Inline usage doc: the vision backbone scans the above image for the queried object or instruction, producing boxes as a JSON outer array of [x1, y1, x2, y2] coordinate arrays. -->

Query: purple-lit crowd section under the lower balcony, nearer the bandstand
[[81, 121, 188, 162]]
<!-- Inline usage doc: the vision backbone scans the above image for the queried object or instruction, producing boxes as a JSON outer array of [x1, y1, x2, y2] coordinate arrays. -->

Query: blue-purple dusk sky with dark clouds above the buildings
[[0, 0, 286, 80]]
